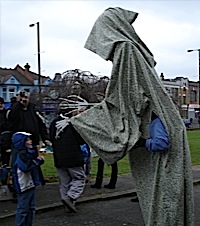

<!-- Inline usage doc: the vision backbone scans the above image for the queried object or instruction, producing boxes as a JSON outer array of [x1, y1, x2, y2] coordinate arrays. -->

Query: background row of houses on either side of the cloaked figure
[[0, 63, 200, 118]]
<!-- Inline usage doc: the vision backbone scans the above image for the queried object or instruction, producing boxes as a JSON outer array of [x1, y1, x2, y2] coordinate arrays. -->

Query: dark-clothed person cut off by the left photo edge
[[0, 97, 11, 166]]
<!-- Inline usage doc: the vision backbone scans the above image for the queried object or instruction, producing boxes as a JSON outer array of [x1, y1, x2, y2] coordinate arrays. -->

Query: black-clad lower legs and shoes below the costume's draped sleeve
[[90, 158, 118, 189]]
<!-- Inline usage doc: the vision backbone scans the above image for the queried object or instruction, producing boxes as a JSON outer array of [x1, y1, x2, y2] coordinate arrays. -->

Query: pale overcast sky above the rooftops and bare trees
[[0, 0, 200, 81]]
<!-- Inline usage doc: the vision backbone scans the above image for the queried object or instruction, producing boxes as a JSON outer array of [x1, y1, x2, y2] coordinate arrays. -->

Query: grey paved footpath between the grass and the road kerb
[[0, 166, 200, 220]]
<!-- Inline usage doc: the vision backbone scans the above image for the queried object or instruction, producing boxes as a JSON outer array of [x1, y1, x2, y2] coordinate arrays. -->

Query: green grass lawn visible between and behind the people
[[42, 130, 200, 179]]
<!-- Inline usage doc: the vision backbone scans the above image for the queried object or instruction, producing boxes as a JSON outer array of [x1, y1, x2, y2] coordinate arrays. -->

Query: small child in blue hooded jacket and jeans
[[12, 132, 44, 226]]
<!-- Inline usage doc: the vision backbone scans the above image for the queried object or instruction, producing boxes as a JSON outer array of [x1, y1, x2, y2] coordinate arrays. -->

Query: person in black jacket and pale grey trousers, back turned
[[50, 103, 85, 213]]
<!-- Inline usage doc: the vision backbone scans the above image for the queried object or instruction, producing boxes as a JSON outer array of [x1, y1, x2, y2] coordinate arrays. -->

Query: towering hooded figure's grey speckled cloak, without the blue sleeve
[[71, 8, 194, 226]]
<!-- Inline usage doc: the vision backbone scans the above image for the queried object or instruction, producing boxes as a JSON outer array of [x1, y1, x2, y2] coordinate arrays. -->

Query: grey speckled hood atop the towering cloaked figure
[[84, 7, 156, 67]]
